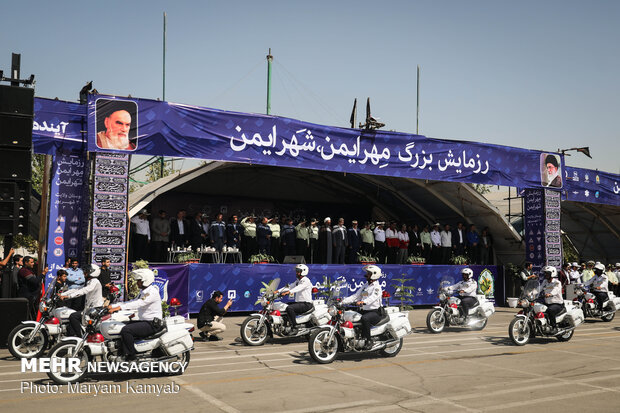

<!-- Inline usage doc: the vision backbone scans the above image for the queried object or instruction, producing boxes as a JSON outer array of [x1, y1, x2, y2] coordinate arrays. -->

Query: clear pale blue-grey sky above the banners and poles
[[0, 0, 620, 173]]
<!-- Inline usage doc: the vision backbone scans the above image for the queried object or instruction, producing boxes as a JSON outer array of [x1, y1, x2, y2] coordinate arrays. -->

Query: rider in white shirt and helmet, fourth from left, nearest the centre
[[342, 265, 383, 350]]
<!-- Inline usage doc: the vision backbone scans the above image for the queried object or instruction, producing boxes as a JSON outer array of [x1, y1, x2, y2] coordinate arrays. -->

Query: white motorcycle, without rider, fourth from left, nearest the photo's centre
[[308, 283, 411, 364]]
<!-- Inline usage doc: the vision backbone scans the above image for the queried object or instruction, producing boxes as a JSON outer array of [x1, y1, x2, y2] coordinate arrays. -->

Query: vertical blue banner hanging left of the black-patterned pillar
[[46, 153, 88, 282]]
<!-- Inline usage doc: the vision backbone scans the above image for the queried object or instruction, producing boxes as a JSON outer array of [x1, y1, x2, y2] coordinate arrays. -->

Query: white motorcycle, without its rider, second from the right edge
[[508, 280, 584, 346]]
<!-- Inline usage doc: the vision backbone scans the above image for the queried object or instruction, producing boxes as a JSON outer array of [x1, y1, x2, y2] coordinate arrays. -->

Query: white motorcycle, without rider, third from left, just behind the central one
[[240, 278, 329, 346]]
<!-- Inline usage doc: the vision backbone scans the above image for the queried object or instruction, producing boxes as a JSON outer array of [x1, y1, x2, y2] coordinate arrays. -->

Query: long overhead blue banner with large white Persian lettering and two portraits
[[83, 95, 563, 187]]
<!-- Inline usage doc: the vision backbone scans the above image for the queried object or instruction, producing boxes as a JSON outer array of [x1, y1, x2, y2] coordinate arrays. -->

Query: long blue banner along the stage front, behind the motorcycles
[[186, 264, 504, 313]]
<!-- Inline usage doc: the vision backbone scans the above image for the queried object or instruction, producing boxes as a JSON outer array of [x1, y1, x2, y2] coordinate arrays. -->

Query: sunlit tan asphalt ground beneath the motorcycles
[[0, 308, 620, 413]]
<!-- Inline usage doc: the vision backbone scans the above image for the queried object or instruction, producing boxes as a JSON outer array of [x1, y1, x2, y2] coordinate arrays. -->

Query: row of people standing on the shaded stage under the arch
[[130, 210, 493, 265]]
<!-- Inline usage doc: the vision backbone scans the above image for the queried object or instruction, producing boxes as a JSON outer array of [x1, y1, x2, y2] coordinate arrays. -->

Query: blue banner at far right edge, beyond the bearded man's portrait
[[562, 166, 620, 206]]
